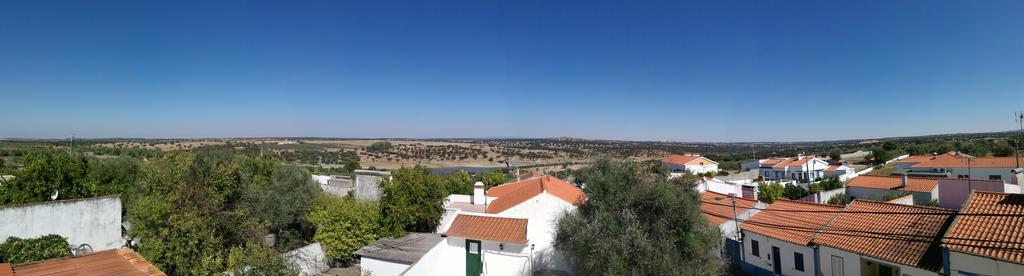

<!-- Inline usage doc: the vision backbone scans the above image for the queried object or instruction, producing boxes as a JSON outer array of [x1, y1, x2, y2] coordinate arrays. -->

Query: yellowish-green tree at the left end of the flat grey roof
[[307, 193, 381, 263]]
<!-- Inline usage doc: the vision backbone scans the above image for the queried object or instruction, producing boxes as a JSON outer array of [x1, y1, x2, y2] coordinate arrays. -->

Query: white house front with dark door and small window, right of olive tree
[[739, 231, 815, 276]]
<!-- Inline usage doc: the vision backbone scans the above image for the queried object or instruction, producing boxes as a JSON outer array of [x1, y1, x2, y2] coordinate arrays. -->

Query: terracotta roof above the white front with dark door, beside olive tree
[[739, 199, 843, 245]]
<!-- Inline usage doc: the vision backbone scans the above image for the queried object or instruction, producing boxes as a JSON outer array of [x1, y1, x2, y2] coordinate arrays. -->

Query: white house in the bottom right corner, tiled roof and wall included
[[942, 191, 1024, 276]]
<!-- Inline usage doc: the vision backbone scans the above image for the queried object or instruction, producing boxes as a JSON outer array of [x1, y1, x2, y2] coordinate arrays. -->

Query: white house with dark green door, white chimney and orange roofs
[[370, 174, 586, 275]]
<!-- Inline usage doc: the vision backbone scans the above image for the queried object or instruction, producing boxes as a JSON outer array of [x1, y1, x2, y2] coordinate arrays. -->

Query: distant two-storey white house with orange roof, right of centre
[[741, 154, 828, 182]]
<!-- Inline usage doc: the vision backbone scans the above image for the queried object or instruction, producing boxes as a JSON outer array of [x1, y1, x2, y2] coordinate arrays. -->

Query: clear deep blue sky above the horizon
[[0, 0, 1024, 141]]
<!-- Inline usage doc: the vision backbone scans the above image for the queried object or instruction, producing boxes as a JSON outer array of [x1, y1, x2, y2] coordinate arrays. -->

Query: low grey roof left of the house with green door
[[355, 233, 443, 264]]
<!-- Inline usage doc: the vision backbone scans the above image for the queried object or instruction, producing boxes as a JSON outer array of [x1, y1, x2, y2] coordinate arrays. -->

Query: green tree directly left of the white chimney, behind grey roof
[[380, 166, 447, 237]]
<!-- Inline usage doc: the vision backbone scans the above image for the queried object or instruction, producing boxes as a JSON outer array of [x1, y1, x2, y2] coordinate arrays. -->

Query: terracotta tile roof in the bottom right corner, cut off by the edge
[[942, 191, 1024, 264]]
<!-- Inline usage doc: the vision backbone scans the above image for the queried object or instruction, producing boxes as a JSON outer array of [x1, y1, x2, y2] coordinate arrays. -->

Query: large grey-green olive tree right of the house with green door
[[555, 158, 721, 275]]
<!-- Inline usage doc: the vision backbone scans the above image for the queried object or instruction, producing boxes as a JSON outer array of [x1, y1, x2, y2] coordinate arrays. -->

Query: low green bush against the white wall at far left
[[0, 234, 71, 264]]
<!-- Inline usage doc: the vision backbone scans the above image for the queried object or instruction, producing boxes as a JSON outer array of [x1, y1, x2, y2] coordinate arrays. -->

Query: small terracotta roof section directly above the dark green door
[[444, 214, 528, 243]]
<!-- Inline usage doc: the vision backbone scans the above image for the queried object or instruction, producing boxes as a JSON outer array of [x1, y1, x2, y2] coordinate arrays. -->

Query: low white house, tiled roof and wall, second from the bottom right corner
[[813, 199, 953, 276]]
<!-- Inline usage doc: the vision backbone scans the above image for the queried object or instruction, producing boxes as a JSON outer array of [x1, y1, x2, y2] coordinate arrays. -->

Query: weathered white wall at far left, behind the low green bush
[[0, 195, 124, 251]]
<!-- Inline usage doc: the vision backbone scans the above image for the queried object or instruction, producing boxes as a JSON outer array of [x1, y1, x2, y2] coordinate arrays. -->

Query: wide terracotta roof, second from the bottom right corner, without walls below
[[814, 199, 953, 271]]
